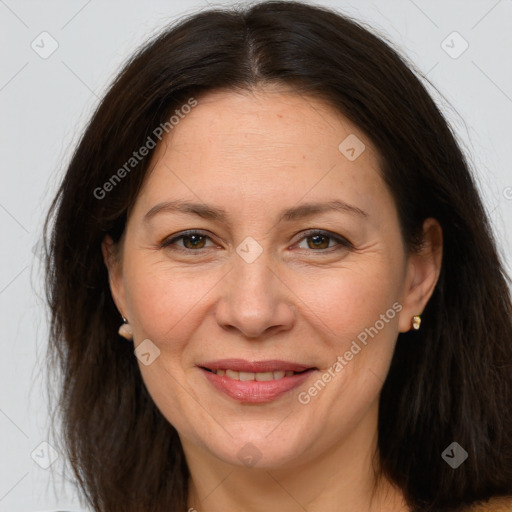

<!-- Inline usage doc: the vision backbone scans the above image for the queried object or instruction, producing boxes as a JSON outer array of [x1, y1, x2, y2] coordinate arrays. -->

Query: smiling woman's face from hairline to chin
[[104, 88, 437, 467]]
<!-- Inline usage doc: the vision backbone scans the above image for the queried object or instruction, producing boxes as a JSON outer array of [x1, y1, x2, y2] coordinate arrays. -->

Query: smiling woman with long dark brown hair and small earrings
[[47, 2, 512, 512]]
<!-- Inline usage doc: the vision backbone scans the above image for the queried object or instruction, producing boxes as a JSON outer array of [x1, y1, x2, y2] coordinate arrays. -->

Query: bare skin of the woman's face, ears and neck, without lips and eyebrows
[[103, 86, 442, 512]]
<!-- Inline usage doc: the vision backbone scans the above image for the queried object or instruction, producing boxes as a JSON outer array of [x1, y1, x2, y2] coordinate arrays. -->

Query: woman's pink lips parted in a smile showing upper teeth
[[198, 359, 317, 403]]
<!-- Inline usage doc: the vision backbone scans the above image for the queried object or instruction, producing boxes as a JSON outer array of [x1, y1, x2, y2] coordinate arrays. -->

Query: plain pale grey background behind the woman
[[0, 0, 512, 512]]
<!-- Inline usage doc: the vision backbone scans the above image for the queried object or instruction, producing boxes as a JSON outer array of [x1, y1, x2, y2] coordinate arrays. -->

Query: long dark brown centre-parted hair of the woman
[[45, 1, 512, 512]]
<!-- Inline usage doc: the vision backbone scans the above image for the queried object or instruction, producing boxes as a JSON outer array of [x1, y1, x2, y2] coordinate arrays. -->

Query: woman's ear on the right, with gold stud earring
[[399, 218, 443, 332]]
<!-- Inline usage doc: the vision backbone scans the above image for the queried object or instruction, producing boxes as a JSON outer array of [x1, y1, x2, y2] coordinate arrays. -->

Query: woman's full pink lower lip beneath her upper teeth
[[201, 368, 314, 404]]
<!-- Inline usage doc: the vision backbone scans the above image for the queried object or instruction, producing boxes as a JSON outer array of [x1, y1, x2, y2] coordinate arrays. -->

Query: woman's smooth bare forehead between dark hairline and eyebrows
[[134, 89, 389, 224]]
